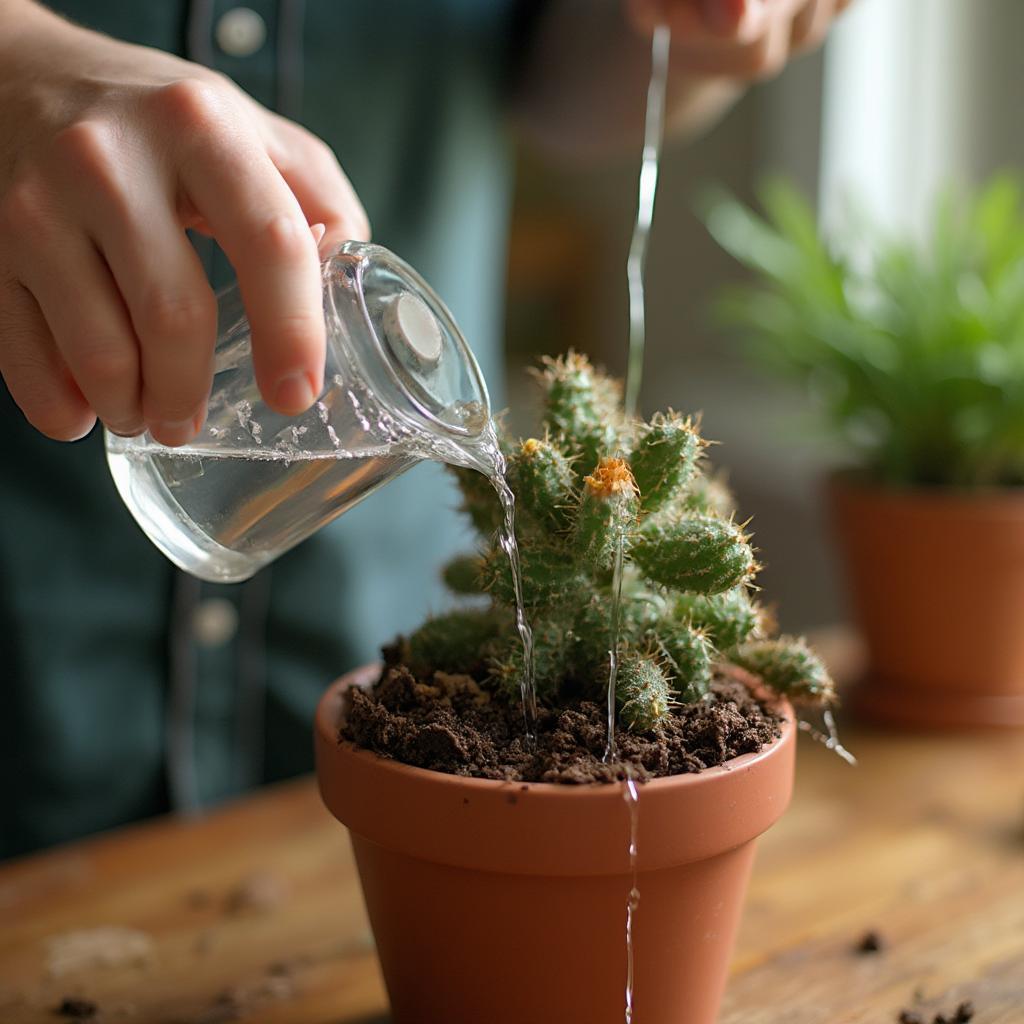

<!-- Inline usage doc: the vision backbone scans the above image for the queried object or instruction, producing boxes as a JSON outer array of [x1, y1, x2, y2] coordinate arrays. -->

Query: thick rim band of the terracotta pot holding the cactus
[[316, 665, 797, 874]]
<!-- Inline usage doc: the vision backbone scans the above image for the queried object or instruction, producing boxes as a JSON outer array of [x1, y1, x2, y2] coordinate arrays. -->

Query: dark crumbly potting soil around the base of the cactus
[[341, 664, 782, 783]]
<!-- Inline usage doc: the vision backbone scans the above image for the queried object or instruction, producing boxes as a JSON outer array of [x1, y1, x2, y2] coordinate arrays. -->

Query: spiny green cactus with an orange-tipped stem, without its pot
[[401, 353, 833, 730]]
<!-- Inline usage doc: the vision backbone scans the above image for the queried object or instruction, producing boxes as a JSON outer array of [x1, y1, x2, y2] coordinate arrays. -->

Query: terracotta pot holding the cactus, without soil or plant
[[316, 668, 796, 1024]]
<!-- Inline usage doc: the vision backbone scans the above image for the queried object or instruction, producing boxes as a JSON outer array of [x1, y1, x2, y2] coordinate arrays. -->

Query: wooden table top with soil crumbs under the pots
[[0, 671, 1024, 1024]]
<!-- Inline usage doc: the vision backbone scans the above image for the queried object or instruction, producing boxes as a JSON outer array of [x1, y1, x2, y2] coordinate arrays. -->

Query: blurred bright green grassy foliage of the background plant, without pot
[[706, 176, 1024, 486]]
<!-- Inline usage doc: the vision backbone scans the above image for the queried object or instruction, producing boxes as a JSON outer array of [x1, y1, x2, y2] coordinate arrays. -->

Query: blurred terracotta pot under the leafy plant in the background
[[828, 475, 1024, 727]]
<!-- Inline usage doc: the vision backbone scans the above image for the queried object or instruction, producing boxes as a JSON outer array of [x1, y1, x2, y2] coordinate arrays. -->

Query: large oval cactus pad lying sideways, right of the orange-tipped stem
[[632, 516, 756, 594]]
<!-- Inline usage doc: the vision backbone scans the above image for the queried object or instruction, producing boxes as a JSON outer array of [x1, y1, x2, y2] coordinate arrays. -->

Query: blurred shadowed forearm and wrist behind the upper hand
[[515, 0, 742, 157]]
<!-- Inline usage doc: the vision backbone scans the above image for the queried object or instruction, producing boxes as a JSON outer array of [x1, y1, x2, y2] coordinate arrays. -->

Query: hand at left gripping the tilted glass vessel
[[0, 0, 370, 445]]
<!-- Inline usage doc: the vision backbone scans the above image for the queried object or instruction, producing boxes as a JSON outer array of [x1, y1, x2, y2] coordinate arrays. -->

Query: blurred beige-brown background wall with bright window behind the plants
[[499, 0, 1024, 631]]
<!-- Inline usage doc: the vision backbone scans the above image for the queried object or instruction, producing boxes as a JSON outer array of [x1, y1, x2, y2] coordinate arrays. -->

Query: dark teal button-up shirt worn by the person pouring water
[[0, 0, 521, 856]]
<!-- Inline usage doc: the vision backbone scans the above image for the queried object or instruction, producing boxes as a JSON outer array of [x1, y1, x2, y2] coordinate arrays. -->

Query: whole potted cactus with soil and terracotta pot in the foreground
[[316, 354, 833, 1024]]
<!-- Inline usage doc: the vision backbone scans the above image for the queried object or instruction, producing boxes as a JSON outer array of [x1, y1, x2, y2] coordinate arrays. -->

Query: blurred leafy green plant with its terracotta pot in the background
[[707, 176, 1024, 726]]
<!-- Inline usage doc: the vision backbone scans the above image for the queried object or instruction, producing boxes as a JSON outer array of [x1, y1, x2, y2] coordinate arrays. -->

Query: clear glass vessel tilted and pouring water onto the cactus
[[105, 242, 490, 583]]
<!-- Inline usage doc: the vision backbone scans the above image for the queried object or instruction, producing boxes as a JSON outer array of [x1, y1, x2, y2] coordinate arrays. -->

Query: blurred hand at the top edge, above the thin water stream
[[625, 0, 850, 81]]
